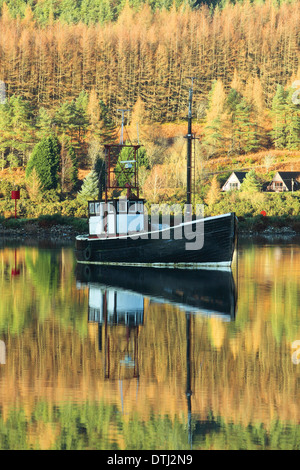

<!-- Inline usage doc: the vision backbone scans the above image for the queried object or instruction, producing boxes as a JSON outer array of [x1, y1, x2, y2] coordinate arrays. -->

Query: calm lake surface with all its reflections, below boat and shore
[[0, 240, 300, 450]]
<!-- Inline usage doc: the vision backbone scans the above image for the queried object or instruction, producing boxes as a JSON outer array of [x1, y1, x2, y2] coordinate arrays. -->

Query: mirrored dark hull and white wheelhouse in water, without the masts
[[77, 265, 236, 323]]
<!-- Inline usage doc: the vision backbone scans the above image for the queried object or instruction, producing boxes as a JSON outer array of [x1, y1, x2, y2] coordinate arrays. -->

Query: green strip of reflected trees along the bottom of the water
[[0, 401, 300, 450]]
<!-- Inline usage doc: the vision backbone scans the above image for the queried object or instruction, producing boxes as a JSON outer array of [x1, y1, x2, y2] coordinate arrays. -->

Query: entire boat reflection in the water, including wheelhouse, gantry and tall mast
[[77, 265, 237, 447]]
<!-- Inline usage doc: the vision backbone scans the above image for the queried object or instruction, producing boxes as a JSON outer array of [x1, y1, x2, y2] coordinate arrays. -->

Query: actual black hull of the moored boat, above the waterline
[[76, 213, 236, 266]]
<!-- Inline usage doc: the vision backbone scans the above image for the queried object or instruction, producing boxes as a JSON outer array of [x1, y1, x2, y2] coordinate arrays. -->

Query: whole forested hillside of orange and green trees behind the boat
[[0, 0, 300, 218]]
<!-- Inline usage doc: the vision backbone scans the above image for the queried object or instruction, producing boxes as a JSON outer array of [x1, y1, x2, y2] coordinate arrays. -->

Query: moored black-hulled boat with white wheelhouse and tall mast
[[75, 88, 237, 269]]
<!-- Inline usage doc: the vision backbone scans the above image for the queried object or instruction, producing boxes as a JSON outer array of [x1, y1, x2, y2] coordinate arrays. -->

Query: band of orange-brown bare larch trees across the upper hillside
[[0, 0, 300, 117]]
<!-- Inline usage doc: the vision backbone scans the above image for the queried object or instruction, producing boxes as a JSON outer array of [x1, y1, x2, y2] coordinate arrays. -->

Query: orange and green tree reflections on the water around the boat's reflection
[[0, 242, 300, 449]]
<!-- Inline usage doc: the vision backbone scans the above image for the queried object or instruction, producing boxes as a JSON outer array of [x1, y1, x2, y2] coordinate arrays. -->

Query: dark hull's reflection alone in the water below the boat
[[76, 264, 237, 320]]
